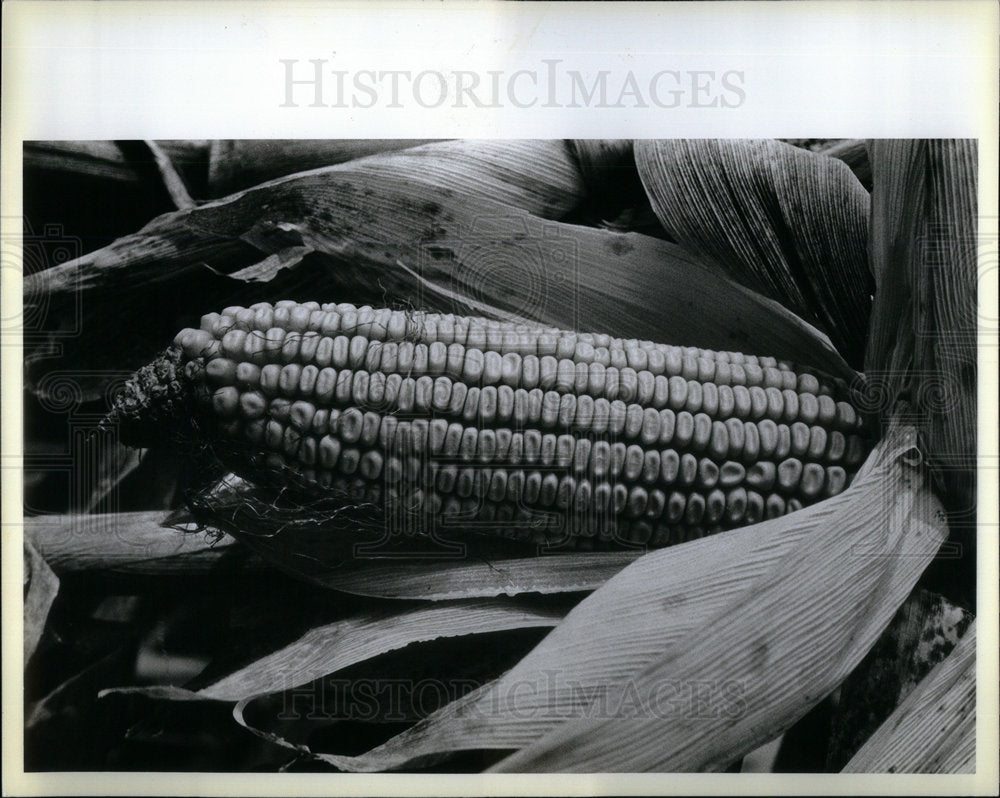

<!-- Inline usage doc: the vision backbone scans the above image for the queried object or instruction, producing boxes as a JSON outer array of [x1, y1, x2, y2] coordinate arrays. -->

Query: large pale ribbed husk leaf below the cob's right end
[[236, 428, 940, 771]]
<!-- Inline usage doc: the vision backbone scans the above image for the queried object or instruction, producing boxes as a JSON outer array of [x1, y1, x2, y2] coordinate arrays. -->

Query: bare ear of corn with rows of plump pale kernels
[[114, 301, 869, 547]]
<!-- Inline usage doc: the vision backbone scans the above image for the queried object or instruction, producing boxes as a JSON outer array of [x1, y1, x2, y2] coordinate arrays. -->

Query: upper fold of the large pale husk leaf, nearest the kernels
[[288, 510, 814, 770]]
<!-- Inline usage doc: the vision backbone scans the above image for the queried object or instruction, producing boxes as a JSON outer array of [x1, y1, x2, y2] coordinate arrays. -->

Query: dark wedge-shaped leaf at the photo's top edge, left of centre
[[207, 139, 444, 197]]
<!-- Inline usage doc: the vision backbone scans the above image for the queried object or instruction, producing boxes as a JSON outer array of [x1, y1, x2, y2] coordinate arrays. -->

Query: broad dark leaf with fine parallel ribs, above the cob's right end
[[635, 140, 872, 366]]
